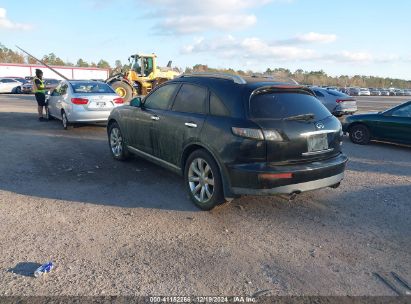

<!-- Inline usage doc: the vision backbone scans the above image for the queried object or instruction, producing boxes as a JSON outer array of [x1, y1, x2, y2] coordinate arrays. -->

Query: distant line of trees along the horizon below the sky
[[0, 43, 411, 88]]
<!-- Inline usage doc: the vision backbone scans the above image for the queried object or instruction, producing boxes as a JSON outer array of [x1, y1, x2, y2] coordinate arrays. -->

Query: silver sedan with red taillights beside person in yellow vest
[[47, 80, 124, 129]]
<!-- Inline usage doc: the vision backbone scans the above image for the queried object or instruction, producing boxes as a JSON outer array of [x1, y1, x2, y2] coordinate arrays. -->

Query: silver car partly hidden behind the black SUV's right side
[[310, 87, 357, 117]]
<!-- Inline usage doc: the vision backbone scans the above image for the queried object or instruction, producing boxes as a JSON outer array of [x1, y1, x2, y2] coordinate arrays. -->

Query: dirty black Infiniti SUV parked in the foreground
[[107, 74, 347, 210]]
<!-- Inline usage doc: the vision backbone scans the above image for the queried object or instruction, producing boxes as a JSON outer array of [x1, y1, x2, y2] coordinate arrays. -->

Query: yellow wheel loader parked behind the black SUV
[[106, 53, 181, 102]]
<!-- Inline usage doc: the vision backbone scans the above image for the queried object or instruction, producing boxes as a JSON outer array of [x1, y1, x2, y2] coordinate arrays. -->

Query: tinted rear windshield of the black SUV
[[250, 92, 331, 120]]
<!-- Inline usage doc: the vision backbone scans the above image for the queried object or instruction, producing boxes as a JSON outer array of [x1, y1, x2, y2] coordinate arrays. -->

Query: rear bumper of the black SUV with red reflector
[[228, 153, 348, 195]]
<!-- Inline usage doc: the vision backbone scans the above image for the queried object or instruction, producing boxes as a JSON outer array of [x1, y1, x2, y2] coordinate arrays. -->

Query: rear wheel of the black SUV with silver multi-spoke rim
[[184, 150, 224, 210]]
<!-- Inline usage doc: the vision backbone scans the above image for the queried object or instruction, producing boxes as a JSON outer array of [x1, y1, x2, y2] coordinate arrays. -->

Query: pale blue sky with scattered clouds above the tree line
[[0, 0, 411, 80]]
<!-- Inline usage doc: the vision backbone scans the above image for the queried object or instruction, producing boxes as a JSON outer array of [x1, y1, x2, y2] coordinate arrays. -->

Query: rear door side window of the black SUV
[[173, 84, 207, 114]]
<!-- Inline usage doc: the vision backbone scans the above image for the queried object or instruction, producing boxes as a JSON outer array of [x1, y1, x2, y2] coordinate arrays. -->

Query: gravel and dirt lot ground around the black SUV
[[0, 95, 411, 295]]
